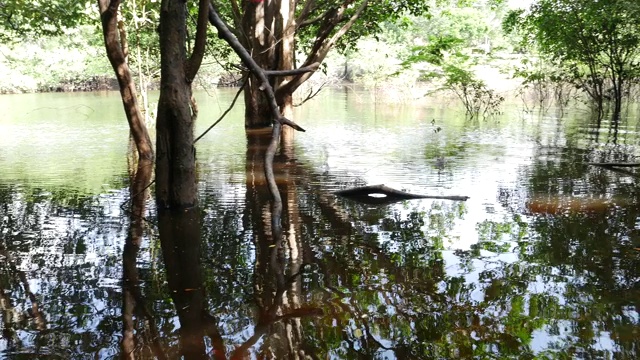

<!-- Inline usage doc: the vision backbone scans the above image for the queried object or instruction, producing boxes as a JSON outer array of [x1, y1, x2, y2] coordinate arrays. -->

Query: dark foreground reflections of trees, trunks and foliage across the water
[[0, 117, 640, 359]]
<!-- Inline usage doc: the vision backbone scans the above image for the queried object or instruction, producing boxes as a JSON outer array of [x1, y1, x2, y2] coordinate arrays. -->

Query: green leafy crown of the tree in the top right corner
[[505, 0, 640, 118]]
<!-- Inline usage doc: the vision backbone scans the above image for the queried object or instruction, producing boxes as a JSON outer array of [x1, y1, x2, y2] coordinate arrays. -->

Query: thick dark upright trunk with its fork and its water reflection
[[156, 0, 216, 359]]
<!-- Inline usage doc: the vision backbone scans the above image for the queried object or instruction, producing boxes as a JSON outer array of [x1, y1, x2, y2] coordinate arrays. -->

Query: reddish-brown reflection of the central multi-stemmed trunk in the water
[[241, 130, 306, 359]]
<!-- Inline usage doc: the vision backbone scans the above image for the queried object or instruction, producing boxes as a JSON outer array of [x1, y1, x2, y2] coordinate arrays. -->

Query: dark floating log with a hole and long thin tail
[[335, 184, 469, 205]]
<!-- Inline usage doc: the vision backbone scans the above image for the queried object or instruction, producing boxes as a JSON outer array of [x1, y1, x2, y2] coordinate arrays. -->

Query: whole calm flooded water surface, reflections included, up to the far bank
[[0, 89, 640, 359]]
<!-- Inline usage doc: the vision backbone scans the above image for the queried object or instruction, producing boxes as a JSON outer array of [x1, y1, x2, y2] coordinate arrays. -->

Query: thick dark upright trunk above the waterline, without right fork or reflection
[[156, 1, 197, 210]]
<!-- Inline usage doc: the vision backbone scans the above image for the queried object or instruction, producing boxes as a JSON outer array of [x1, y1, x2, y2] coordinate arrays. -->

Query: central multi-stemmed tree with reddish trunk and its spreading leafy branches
[[215, 0, 428, 127]]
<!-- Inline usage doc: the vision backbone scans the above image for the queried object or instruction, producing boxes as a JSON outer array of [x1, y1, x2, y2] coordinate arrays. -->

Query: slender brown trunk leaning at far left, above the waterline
[[98, 0, 153, 160]]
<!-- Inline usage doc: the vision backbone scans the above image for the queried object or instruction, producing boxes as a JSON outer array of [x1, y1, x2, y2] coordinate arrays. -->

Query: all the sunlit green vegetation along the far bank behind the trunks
[[0, 0, 640, 119]]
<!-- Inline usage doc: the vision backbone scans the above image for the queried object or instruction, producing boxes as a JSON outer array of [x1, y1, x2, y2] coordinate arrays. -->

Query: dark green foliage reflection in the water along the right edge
[[510, 137, 640, 358]]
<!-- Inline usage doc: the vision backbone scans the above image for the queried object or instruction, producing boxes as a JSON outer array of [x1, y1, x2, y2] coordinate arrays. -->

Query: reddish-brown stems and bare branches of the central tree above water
[[234, 0, 370, 129]]
